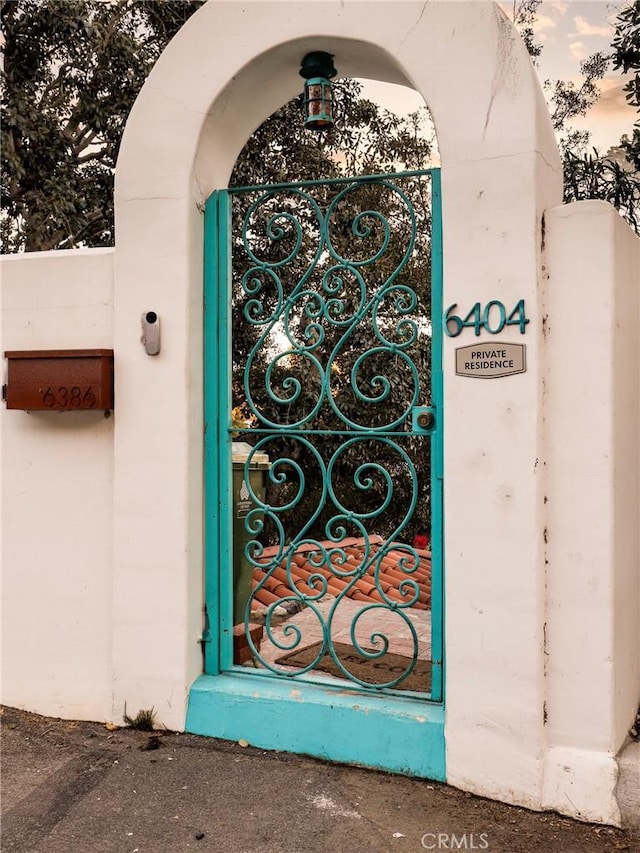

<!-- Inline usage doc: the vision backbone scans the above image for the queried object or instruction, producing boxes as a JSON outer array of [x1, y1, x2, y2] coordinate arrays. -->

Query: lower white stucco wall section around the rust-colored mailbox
[[0, 249, 115, 720]]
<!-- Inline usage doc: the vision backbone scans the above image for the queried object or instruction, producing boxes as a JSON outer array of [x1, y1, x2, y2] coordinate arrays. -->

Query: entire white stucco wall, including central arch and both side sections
[[0, 0, 640, 822]]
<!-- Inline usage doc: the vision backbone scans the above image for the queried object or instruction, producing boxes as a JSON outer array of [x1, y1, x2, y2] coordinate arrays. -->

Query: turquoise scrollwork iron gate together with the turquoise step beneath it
[[187, 170, 444, 778]]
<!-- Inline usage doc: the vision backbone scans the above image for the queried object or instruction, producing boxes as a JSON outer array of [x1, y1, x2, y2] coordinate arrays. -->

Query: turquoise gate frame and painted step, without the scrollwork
[[185, 169, 446, 781]]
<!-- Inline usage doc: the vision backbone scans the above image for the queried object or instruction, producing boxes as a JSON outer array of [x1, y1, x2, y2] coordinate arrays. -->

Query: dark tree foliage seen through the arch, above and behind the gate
[[231, 80, 431, 544]]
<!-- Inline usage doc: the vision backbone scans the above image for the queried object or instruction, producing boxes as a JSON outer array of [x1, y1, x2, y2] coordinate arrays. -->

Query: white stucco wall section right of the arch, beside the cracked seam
[[544, 201, 640, 821]]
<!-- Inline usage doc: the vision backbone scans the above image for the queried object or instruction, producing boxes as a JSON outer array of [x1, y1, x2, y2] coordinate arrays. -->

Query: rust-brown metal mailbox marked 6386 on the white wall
[[4, 349, 113, 412]]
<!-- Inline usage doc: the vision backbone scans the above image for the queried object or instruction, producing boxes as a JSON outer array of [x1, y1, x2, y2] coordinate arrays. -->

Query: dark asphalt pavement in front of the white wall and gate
[[1, 708, 640, 853]]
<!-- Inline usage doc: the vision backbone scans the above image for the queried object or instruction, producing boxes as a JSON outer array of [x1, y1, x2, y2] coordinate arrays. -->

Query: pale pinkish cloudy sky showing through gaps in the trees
[[363, 0, 638, 153]]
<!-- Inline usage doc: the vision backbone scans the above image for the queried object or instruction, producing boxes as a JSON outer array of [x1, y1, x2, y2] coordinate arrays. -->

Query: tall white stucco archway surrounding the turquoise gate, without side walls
[[113, 0, 561, 805]]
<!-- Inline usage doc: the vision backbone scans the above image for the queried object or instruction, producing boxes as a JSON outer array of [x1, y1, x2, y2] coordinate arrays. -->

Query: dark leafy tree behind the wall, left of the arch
[[0, 0, 201, 252]]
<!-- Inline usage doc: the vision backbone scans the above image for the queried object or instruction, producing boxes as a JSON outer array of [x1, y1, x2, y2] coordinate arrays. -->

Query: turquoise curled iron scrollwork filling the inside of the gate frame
[[229, 172, 432, 690]]
